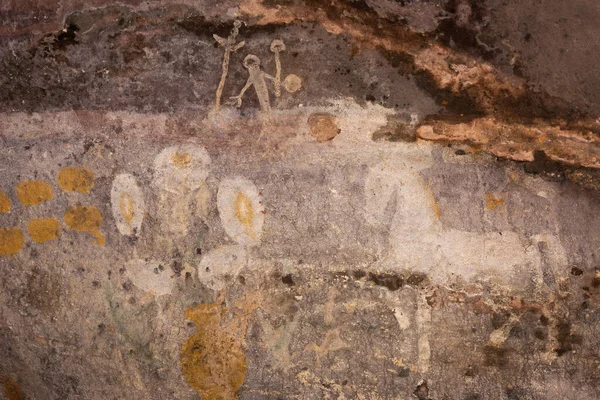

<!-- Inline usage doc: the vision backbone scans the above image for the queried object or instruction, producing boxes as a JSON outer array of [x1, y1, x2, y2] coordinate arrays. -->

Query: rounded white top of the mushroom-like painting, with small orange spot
[[154, 144, 210, 192]]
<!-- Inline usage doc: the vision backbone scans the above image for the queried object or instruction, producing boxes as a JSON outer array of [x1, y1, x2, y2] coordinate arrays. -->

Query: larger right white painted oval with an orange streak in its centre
[[217, 177, 265, 246]]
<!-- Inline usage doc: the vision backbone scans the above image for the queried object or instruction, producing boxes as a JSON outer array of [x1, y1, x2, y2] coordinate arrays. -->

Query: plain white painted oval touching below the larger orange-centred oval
[[198, 245, 248, 290]]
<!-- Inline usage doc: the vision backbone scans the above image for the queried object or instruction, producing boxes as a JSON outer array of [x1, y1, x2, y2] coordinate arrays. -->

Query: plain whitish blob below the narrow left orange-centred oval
[[125, 258, 173, 296]]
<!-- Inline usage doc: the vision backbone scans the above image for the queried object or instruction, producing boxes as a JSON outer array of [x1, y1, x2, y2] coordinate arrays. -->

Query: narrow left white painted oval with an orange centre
[[110, 174, 146, 236]]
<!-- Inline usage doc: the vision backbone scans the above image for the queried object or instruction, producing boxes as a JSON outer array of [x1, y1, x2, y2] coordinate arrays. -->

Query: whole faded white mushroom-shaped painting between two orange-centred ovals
[[153, 145, 211, 237]]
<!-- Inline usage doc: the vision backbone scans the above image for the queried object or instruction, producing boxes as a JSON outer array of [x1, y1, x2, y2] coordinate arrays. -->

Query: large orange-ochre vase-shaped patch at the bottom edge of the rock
[[180, 304, 246, 400]]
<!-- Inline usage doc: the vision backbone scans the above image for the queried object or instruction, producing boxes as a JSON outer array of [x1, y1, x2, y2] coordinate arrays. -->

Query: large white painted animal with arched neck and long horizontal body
[[365, 155, 565, 290]]
